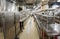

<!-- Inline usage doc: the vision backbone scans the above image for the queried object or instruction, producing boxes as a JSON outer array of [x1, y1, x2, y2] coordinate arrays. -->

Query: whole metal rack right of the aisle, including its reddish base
[[34, 9, 60, 39]]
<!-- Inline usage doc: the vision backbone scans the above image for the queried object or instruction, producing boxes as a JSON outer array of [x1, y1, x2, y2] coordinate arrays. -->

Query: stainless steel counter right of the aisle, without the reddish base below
[[35, 14, 60, 36]]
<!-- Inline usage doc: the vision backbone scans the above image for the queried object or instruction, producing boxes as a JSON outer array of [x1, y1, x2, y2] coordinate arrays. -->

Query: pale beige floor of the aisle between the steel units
[[19, 17, 39, 39]]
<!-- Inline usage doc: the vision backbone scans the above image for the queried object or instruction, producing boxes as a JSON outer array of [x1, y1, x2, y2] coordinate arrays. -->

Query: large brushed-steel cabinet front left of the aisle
[[0, 12, 20, 39]]
